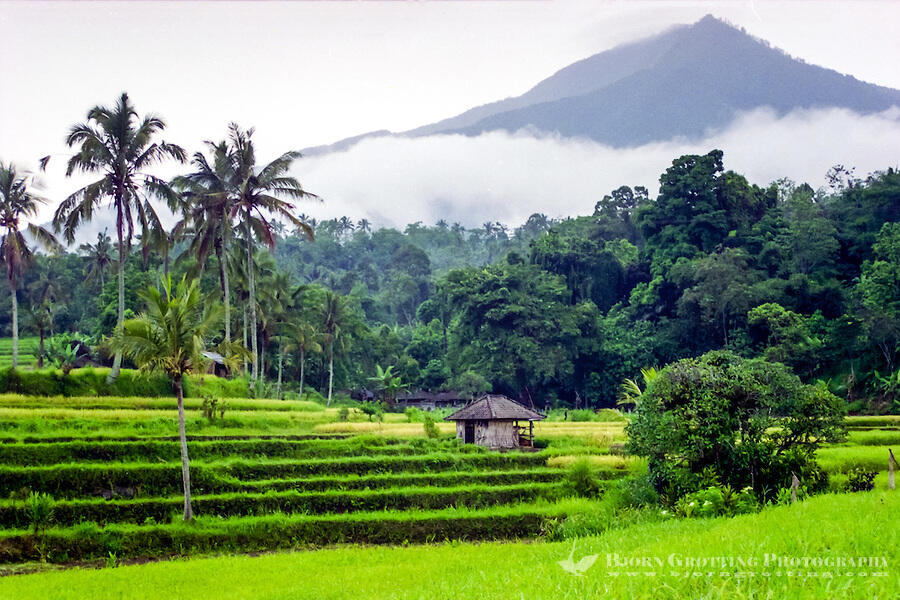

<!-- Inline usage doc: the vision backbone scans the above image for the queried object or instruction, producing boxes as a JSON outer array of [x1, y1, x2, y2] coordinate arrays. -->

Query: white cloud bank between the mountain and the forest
[[294, 108, 900, 227]]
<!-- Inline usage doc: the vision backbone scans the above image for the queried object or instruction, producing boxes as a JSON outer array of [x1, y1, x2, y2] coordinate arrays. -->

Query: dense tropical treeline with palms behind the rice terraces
[[0, 96, 900, 411]]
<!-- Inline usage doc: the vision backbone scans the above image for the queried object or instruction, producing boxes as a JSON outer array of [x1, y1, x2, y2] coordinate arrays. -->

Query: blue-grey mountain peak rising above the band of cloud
[[304, 15, 900, 155]]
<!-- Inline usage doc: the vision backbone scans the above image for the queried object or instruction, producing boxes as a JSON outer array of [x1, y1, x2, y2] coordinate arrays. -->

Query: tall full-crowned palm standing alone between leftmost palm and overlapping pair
[[53, 93, 184, 382]]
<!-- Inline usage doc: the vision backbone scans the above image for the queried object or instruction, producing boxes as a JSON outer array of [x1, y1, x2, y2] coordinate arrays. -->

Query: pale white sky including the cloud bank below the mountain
[[0, 0, 900, 232]]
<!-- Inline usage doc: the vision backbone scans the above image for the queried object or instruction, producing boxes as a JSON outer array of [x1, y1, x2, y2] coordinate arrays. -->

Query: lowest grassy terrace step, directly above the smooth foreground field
[[0, 500, 596, 562]]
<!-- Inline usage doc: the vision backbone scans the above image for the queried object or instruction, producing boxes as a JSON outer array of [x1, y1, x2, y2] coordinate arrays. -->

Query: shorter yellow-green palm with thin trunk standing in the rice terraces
[[112, 277, 222, 521]]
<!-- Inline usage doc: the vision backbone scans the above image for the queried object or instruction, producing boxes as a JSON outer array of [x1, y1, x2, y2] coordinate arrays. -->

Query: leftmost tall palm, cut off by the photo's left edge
[[0, 162, 61, 369]]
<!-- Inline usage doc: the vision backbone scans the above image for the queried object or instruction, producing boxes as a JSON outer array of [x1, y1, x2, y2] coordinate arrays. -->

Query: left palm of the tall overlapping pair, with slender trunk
[[172, 141, 233, 344]]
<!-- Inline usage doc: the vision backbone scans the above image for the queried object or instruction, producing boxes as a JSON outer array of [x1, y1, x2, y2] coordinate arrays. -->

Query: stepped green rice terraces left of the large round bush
[[0, 395, 635, 563]]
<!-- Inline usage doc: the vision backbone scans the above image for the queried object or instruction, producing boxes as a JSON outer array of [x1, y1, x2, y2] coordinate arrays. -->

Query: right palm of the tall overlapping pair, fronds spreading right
[[219, 123, 317, 385]]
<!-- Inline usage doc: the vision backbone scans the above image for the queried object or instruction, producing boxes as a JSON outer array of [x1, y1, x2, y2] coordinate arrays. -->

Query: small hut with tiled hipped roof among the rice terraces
[[446, 394, 546, 450]]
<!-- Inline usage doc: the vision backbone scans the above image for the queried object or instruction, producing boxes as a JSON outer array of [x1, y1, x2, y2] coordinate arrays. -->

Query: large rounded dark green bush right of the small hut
[[626, 351, 845, 501]]
